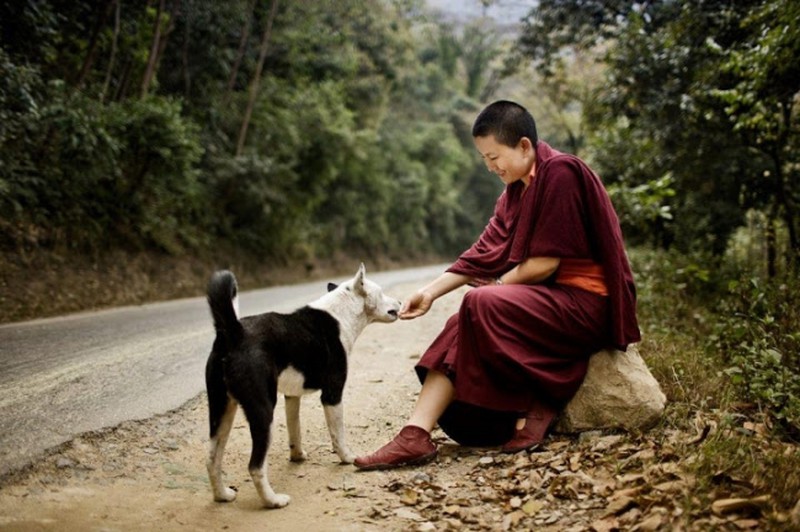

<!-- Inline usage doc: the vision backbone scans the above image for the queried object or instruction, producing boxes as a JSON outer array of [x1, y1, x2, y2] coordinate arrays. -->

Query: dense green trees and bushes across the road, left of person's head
[[0, 0, 499, 262]]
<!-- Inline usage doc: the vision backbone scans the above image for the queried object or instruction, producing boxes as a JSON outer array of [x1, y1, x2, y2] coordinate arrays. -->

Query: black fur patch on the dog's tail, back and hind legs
[[206, 272, 347, 469]]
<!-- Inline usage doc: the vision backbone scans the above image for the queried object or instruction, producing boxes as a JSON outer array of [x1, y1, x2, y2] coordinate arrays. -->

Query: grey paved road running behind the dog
[[0, 265, 445, 478]]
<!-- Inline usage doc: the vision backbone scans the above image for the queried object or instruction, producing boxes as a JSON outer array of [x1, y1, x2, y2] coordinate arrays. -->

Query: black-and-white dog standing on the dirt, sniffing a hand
[[206, 263, 400, 508]]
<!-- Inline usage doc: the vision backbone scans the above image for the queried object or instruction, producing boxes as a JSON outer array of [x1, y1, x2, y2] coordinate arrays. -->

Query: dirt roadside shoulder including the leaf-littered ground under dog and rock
[[0, 280, 800, 532]]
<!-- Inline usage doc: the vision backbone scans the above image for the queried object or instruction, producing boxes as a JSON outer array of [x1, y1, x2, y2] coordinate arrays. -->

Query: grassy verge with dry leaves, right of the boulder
[[632, 250, 800, 529]]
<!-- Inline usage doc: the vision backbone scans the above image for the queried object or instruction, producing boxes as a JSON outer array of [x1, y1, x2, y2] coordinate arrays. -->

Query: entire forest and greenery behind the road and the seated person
[[0, 0, 800, 524]]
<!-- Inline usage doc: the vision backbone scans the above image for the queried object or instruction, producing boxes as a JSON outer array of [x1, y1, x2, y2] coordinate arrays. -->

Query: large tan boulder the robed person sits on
[[554, 345, 667, 433]]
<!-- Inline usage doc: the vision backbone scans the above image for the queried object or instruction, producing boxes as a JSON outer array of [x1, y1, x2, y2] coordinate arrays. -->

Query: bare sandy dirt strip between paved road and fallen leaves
[[0, 280, 476, 530]]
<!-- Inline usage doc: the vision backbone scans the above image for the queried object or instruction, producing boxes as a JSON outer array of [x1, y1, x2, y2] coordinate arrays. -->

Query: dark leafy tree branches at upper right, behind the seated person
[[519, 0, 800, 263]]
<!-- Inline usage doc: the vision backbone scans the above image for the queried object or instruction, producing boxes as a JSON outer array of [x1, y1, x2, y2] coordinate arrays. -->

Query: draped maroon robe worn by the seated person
[[416, 141, 640, 445]]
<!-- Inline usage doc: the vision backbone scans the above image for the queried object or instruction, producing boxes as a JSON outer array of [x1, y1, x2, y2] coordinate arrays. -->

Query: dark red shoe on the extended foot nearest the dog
[[353, 425, 437, 471]]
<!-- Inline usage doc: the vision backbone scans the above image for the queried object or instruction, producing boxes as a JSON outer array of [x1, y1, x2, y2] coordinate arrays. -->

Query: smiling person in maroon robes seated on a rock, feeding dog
[[355, 101, 640, 470]]
